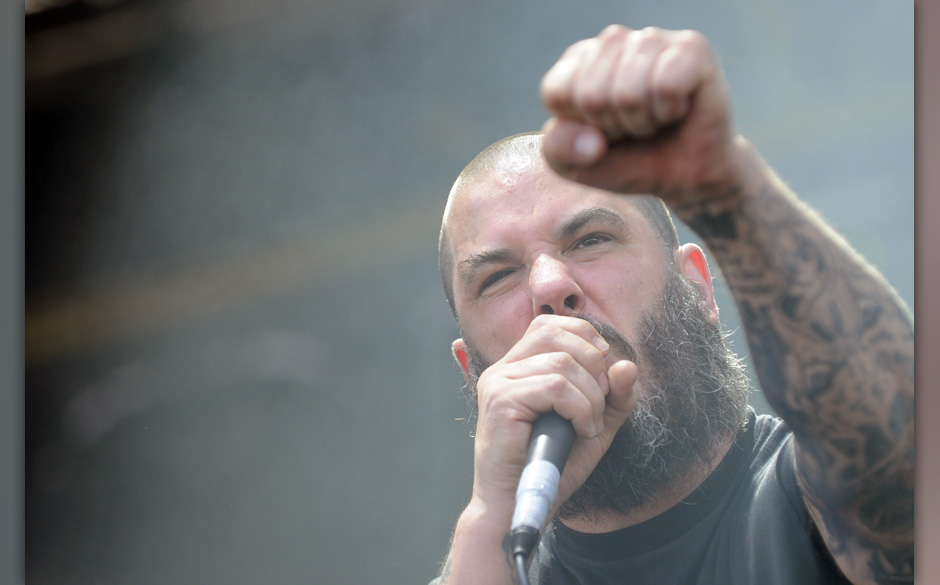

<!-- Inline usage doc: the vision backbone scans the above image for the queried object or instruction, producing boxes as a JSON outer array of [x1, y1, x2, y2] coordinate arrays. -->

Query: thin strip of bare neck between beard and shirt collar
[[561, 434, 735, 534]]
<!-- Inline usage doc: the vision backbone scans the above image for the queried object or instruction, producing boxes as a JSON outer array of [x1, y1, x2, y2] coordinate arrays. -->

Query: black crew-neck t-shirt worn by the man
[[530, 411, 848, 585]]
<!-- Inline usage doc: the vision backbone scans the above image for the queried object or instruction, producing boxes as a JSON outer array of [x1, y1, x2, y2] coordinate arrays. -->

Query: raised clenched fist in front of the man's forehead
[[541, 25, 743, 204]]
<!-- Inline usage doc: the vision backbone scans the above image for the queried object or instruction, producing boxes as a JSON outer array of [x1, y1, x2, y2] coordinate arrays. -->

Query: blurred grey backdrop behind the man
[[24, 0, 914, 585]]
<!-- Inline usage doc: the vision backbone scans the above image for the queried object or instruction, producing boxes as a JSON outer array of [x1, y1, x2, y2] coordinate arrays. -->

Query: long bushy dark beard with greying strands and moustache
[[467, 271, 749, 518]]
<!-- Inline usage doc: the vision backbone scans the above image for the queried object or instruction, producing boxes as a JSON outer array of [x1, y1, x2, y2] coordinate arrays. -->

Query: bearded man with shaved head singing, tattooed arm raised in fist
[[437, 26, 914, 585]]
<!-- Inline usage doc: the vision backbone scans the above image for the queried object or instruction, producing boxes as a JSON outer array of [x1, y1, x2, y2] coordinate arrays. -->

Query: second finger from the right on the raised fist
[[608, 27, 666, 140]]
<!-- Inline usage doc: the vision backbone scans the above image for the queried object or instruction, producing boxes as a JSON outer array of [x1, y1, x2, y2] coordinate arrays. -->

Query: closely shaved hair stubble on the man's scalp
[[438, 132, 679, 318]]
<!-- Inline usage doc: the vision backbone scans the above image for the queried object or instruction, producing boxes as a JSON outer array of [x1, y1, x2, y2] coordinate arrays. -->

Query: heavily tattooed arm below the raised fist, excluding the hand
[[674, 140, 914, 577]]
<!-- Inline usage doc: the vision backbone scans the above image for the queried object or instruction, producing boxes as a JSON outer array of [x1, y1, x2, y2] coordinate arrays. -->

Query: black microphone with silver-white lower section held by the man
[[511, 411, 574, 558]]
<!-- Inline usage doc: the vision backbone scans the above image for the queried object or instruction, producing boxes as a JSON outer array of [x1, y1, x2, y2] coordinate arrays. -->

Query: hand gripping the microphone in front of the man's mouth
[[474, 315, 637, 516]]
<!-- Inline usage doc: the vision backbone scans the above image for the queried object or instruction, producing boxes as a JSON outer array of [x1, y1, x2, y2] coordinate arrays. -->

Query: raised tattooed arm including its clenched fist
[[542, 26, 914, 584]]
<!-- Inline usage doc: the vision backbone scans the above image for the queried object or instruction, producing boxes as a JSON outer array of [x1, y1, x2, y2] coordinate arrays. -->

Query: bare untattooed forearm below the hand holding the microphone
[[437, 502, 516, 585]]
